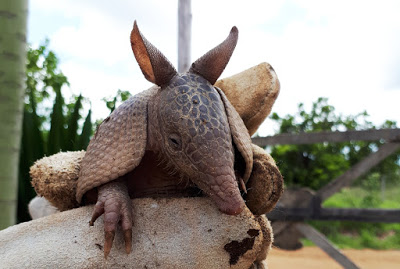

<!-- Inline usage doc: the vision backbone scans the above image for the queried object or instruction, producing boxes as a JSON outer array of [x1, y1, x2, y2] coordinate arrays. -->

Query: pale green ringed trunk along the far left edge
[[0, 0, 28, 230]]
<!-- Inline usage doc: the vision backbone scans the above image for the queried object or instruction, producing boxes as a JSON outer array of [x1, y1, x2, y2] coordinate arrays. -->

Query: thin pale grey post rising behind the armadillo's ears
[[178, 0, 192, 73]]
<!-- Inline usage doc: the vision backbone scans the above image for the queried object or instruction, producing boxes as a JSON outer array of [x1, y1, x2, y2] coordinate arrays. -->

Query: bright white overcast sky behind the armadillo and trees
[[28, 0, 400, 135]]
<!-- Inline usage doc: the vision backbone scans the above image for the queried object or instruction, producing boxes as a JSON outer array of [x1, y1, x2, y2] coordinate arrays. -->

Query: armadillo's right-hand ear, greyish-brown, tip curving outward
[[189, 26, 239, 85]]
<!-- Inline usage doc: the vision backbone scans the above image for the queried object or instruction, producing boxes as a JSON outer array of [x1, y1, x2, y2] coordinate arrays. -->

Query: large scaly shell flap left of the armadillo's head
[[76, 87, 158, 203]]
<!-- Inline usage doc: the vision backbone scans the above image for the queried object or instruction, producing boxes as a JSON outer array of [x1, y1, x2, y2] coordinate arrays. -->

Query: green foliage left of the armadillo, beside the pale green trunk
[[18, 41, 93, 222]]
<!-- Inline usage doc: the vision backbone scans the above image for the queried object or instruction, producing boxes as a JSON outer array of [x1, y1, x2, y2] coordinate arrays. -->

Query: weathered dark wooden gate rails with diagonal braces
[[252, 129, 400, 269]]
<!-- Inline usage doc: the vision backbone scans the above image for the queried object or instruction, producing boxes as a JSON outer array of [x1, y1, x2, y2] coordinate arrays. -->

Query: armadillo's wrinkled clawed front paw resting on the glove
[[89, 181, 132, 258]]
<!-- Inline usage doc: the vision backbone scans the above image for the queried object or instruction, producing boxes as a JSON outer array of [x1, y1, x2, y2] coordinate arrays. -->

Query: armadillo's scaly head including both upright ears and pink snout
[[131, 22, 244, 215]]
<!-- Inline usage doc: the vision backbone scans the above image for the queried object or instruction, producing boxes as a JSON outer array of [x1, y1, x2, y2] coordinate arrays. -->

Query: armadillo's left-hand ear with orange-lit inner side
[[131, 21, 177, 86]]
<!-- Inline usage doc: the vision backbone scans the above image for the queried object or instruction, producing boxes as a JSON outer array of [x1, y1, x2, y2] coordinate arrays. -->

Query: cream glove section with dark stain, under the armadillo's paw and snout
[[0, 198, 272, 269]]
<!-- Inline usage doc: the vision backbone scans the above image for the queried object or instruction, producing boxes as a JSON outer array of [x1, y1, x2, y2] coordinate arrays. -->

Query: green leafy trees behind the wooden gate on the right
[[271, 98, 400, 190]]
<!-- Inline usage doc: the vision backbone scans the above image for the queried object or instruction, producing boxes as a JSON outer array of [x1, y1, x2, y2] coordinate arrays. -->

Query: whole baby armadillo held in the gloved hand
[[76, 21, 253, 257]]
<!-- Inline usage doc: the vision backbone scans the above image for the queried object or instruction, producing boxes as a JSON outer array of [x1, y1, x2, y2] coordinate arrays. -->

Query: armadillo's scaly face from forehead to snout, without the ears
[[148, 73, 244, 215]]
